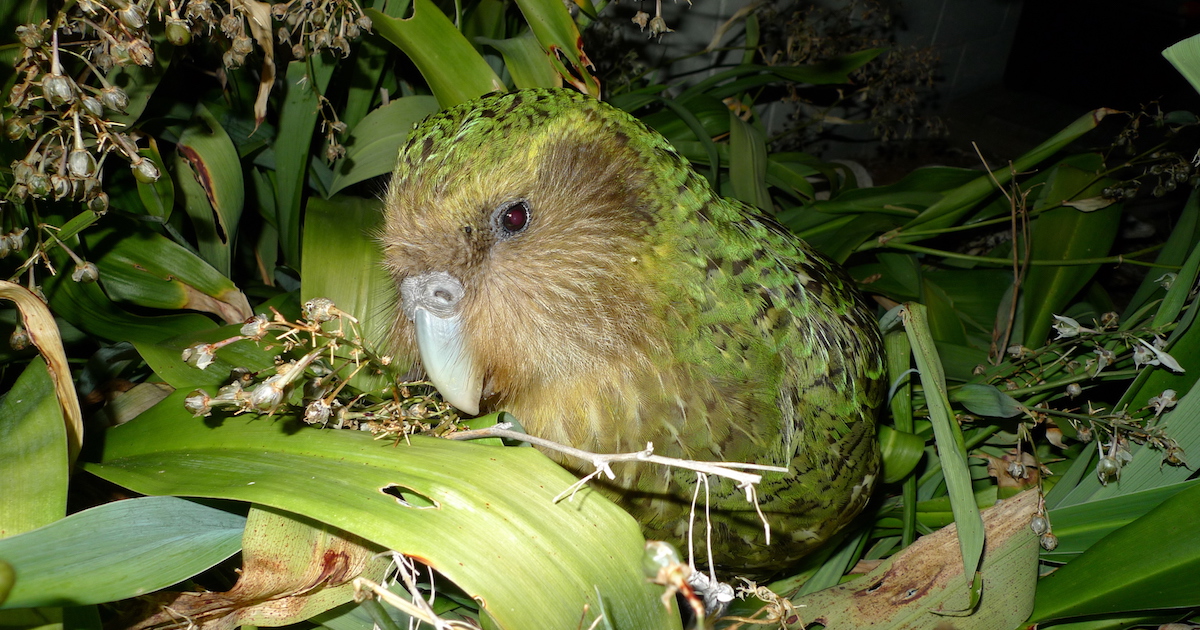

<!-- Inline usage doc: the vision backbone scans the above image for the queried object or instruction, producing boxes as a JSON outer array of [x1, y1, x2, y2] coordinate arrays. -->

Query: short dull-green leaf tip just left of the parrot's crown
[[329, 96, 438, 194]]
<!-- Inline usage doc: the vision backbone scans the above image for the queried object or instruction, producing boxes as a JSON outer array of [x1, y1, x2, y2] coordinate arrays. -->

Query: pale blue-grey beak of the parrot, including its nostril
[[400, 271, 484, 414]]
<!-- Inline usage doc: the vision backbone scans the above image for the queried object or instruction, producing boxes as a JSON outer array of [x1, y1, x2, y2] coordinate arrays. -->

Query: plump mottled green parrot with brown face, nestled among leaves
[[382, 89, 884, 575]]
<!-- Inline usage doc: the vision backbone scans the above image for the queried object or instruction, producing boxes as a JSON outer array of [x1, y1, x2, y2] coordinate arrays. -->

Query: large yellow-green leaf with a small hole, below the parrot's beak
[[88, 392, 679, 630]]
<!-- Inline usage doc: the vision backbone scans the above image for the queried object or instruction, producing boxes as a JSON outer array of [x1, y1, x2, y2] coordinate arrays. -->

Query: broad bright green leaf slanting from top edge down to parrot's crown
[[366, 0, 504, 108]]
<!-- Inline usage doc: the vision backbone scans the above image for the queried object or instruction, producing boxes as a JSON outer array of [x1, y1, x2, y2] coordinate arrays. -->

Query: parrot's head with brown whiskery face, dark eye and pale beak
[[382, 90, 685, 414]]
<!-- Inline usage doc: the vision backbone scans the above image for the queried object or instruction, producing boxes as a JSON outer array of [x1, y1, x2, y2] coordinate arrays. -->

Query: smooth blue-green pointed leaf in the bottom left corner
[[0, 497, 246, 608]]
